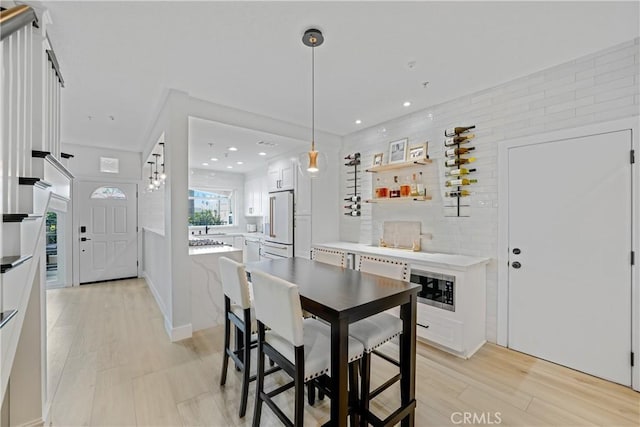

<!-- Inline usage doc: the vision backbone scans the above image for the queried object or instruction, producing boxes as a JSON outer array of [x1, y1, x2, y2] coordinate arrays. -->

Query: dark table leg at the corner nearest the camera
[[331, 319, 349, 426]]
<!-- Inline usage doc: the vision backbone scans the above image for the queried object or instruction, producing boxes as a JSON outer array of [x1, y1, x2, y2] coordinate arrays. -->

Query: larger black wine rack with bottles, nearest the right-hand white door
[[444, 125, 478, 217]]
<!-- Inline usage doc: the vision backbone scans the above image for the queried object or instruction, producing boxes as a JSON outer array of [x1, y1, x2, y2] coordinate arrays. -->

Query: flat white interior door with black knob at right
[[508, 130, 632, 385]]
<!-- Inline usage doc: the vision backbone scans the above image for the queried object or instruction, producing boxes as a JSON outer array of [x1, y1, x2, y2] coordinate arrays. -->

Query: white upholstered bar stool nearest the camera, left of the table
[[251, 270, 364, 427]]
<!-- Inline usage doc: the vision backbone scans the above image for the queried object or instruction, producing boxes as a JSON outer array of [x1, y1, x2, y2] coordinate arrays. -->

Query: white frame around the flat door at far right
[[496, 116, 640, 391]]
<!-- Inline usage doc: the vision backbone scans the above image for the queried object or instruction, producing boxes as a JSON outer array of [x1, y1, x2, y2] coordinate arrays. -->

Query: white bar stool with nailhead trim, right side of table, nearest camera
[[349, 255, 409, 425]]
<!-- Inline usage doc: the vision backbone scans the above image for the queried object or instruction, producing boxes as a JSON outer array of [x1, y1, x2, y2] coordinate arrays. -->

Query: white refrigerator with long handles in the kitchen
[[261, 191, 293, 259]]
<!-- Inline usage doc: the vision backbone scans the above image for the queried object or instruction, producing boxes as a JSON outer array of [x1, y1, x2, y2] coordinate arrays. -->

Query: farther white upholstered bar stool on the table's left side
[[218, 257, 258, 418]]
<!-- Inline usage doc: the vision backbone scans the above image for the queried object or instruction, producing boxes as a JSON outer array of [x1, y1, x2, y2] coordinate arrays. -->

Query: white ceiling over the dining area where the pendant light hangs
[[44, 1, 640, 171]]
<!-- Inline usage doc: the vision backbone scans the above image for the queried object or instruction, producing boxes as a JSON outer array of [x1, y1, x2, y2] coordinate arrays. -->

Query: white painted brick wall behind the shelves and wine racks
[[340, 38, 640, 342]]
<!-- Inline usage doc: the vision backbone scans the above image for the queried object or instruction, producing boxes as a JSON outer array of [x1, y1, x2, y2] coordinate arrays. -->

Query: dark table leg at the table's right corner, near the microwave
[[400, 295, 417, 427]]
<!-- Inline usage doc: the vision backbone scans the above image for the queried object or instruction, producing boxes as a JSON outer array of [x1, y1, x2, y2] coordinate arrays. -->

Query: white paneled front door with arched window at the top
[[78, 182, 138, 283]]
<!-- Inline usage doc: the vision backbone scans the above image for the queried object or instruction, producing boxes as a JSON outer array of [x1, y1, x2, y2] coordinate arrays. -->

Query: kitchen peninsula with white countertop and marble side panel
[[189, 245, 242, 331]]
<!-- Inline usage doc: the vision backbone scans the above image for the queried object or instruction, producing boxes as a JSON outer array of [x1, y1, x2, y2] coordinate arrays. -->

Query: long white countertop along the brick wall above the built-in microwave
[[314, 242, 489, 269]]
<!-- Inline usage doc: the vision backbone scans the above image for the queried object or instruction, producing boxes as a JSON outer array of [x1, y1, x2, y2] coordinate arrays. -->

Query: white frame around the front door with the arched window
[[71, 177, 142, 286]]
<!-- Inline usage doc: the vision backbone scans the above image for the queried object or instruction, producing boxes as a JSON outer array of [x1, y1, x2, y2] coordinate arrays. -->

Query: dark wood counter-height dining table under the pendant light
[[246, 258, 421, 426]]
